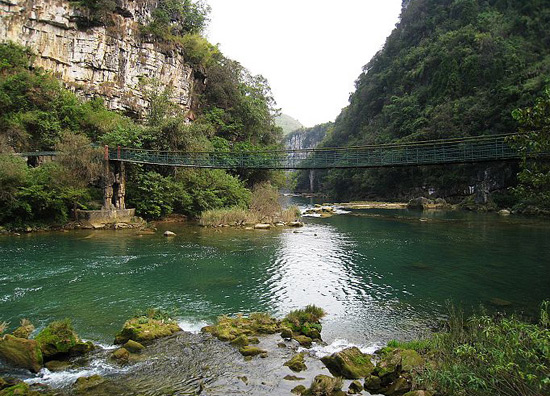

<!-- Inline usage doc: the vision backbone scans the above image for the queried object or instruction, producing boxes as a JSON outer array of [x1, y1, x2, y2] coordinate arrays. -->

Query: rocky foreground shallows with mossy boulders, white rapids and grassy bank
[[0, 302, 550, 396]]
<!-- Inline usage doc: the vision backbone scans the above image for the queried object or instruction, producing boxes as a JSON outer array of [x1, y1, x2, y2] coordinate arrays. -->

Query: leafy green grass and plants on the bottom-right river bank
[[389, 302, 550, 396]]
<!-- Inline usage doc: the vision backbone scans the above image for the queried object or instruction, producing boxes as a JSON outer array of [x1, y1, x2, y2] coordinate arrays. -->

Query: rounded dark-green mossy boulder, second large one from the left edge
[[34, 319, 80, 360]]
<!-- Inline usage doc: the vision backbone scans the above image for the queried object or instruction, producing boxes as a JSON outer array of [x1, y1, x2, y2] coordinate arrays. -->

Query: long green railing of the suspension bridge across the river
[[109, 135, 520, 169]]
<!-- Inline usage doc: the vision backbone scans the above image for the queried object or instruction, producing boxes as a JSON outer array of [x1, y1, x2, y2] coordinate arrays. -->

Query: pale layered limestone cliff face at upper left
[[0, 0, 198, 117]]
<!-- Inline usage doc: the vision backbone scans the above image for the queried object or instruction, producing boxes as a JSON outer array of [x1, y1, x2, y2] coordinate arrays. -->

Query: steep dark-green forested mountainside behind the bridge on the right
[[310, 0, 550, 203]]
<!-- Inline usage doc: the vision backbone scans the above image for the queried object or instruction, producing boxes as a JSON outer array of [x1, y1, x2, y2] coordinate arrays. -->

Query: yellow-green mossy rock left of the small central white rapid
[[115, 317, 181, 344]]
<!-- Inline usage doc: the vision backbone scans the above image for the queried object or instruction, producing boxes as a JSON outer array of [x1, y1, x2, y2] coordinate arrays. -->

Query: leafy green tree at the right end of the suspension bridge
[[513, 89, 550, 208]]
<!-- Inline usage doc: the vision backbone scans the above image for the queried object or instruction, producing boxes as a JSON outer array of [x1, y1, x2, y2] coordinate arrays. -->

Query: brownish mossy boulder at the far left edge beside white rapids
[[0, 334, 44, 373]]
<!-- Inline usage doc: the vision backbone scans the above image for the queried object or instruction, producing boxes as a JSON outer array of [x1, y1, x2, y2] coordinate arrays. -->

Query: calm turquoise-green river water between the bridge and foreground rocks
[[0, 210, 550, 345]]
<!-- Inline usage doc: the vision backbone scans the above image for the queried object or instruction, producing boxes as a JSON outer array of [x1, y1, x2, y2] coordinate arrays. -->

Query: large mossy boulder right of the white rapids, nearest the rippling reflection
[[321, 347, 374, 379]]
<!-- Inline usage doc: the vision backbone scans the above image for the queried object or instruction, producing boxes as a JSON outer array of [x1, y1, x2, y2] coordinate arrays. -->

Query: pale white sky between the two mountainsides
[[206, 0, 401, 127]]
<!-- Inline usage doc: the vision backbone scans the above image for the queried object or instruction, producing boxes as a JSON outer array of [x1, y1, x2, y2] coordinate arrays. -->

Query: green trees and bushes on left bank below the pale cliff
[[0, 18, 281, 227]]
